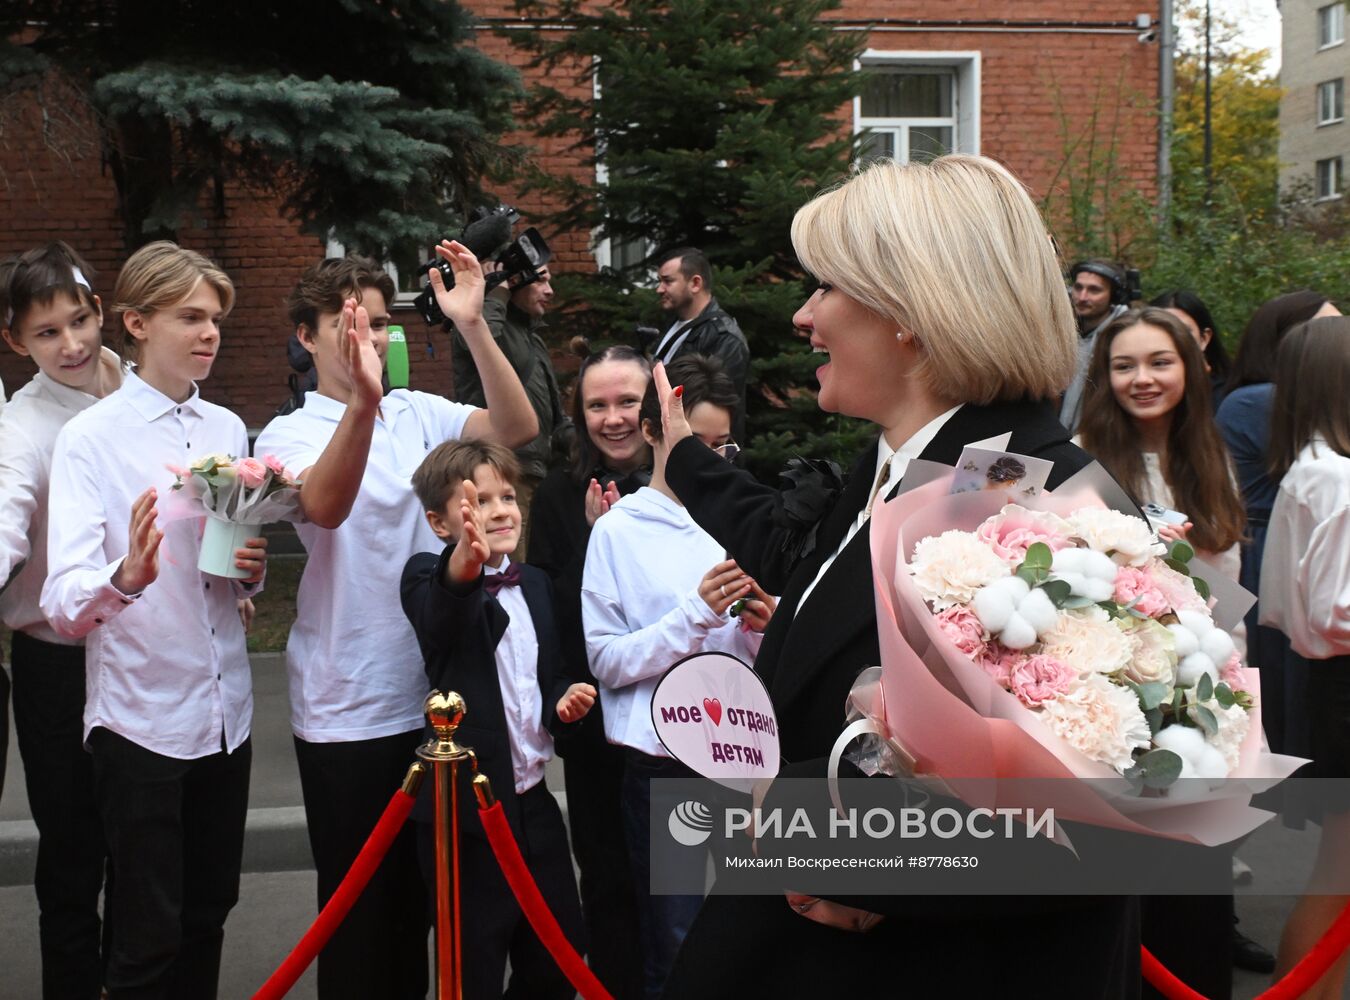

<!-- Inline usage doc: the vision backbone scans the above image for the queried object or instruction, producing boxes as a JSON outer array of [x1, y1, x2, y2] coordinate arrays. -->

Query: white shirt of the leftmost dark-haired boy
[[0, 347, 122, 645]]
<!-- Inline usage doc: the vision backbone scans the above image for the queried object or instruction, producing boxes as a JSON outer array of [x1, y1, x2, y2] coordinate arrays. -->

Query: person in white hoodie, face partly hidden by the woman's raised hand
[[582, 355, 775, 997]]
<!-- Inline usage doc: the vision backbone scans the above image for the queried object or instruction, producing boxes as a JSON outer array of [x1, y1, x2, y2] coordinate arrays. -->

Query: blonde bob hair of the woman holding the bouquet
[[792, 155, 1077, 404]]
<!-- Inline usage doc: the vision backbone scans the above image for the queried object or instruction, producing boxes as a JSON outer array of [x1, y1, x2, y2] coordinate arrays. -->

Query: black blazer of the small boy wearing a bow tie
[[401, 548, 570, 838]]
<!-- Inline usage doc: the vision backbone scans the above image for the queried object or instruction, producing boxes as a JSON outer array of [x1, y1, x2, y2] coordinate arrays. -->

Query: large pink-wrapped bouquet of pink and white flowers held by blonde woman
[[836, 458, 1301, 843]]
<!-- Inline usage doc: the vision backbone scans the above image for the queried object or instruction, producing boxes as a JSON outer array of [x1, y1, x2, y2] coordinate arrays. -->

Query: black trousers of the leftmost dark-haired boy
[[11, 632, 108, 1000]]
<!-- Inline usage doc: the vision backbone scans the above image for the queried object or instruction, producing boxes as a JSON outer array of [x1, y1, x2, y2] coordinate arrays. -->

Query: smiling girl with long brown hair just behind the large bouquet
[[1079, 306, 1243, 569]]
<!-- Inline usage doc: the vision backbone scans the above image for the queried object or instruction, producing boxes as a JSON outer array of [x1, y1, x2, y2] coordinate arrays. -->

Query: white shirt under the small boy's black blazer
[[483, 557, 554, 795]]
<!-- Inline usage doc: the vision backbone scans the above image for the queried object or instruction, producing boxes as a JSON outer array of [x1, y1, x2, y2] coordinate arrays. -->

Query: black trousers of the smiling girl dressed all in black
[[563, 723, 643, 1000]]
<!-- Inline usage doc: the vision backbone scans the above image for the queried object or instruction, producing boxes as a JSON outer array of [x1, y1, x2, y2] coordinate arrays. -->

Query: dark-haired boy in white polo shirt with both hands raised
[[255, 242, 537, 1000]]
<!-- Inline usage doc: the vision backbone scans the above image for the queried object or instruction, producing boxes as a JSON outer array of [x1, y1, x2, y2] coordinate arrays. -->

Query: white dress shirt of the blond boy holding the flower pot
[[42, 374, 252, 760]]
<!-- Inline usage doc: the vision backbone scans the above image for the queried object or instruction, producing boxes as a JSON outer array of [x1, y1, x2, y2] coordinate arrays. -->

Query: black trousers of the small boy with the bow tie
[[417, 781, 586, 1000]]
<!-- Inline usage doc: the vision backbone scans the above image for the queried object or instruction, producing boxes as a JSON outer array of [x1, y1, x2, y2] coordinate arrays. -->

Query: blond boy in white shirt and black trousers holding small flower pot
[[42, 242, 266, 999]]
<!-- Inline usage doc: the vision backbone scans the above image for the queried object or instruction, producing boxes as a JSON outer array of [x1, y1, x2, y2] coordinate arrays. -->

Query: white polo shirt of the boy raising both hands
[[254, 389, 477, 744]]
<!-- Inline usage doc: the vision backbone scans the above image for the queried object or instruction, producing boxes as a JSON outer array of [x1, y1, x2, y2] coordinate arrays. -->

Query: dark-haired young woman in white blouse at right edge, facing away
[[1261, 316, 1350, 1000]]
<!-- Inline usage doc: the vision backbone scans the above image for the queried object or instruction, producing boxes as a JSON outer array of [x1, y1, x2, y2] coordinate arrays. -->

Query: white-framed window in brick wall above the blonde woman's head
[[853, 50, 980, 163]]
